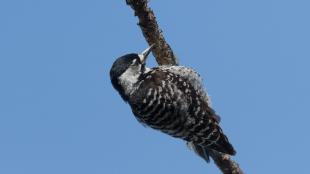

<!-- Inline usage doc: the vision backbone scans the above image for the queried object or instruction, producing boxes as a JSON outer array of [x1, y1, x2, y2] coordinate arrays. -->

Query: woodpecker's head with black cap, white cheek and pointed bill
[[110, 45, 154, 101]]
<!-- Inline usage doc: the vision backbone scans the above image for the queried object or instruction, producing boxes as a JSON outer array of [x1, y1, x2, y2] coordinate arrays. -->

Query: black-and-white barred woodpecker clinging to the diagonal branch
[[110, 45, 236, 162]]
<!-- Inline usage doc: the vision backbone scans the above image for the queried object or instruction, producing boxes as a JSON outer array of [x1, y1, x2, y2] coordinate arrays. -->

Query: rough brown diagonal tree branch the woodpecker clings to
[[126, 0, 244, 174]]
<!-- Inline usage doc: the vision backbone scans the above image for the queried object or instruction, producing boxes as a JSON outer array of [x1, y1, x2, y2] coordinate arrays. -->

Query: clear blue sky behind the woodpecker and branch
[[0, 0, 310, 174]]
